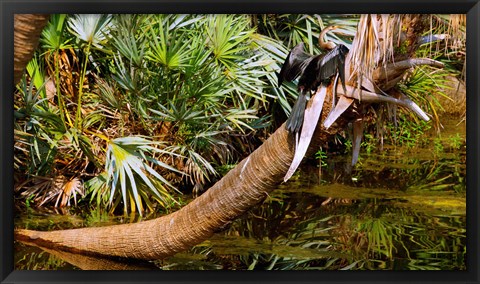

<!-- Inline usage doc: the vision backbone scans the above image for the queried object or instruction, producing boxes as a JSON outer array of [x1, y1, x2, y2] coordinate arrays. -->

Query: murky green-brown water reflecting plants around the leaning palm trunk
[[15, 118, 467, 270]]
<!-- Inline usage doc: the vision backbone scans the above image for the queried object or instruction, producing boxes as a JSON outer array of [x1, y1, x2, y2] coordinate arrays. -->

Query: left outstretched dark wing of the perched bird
[[278, 42, 312, 87]]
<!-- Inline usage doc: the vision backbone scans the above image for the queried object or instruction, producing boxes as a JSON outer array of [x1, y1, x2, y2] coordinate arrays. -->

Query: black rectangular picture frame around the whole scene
[[0, 0, 480, 283]]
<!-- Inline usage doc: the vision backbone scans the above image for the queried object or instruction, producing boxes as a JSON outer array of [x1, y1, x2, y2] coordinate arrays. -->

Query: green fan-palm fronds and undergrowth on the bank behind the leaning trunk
[[14, 15, 462, 217]]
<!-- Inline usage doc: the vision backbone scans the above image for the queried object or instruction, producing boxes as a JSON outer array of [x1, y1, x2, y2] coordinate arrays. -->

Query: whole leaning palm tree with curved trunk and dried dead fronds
[[15, 15, 458, 260]]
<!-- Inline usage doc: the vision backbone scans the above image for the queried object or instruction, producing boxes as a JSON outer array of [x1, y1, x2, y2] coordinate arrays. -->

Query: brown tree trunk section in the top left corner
[[13, 14, 50, 85]]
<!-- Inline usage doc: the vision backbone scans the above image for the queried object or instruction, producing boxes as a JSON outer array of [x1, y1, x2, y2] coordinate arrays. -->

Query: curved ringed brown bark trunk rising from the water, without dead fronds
[[15, 98, 345, 260]]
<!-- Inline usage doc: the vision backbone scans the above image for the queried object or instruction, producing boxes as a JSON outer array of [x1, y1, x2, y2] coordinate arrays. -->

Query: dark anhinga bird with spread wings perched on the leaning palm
[[278, 26, 348, 133]]
